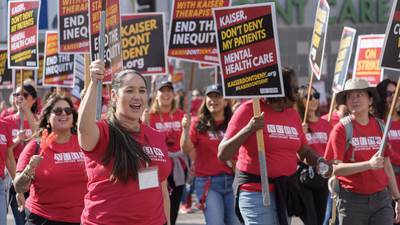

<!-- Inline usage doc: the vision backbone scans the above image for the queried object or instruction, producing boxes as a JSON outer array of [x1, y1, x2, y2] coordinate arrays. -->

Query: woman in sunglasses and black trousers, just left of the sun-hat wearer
[[297, 86, 332, 224]]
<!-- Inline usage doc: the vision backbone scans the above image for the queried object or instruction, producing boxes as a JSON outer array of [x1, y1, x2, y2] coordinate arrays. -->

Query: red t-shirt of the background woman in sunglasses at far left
[[4, 114, 32, 160]]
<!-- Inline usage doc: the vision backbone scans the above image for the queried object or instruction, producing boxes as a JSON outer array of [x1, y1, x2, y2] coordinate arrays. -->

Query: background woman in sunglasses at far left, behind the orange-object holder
[[4, 84, 38, 225]]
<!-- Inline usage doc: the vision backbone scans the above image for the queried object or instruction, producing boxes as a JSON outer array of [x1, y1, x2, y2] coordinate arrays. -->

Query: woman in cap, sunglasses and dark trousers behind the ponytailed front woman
[[149, 81, 187, 225]]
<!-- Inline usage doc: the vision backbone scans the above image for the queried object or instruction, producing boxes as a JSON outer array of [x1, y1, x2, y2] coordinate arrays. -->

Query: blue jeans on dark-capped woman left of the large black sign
[[195, 174, 240, 225]]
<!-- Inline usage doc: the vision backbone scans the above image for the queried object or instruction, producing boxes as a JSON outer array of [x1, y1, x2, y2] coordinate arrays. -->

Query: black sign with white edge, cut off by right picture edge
[[381, 0, 400, 70]]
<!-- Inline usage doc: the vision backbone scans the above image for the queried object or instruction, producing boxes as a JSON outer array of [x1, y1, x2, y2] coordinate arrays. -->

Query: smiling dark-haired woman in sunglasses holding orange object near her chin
[[14, 96, 87, 225]]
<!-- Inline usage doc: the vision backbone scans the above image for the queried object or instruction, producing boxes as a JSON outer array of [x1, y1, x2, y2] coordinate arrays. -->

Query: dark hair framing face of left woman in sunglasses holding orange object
[[39, 95, 78, 137]]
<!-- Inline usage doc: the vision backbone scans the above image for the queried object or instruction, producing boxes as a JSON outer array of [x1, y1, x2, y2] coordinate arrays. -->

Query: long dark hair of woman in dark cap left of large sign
[[196, 97, 233, 133]]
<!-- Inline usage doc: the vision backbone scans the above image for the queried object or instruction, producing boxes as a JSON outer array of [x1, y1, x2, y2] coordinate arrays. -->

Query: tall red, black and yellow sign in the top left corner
[[7, 0, 40, 70]]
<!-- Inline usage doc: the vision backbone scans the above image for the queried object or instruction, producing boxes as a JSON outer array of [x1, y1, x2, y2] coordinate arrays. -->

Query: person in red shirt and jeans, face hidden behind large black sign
[[218, 68, 326, 225]]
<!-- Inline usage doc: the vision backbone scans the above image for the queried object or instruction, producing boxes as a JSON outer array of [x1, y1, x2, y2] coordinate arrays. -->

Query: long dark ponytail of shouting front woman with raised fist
[[102, 70, 151, 182]]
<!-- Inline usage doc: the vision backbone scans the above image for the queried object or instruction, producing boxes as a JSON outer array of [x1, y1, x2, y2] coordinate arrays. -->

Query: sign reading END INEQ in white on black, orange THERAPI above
[[58, 0, 89, 54]]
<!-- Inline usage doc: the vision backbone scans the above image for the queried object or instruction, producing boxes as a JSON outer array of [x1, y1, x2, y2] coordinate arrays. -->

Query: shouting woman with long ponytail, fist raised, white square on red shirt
[[78, 60, 171, 225]]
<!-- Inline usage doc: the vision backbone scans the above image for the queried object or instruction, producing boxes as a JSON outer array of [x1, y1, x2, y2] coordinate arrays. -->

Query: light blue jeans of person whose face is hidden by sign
[[239, 191, 291, 225]]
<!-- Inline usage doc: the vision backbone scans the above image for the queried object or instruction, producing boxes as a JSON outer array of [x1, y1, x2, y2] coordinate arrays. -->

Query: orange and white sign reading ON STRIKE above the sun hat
[[353, 34, 385, 86]]
